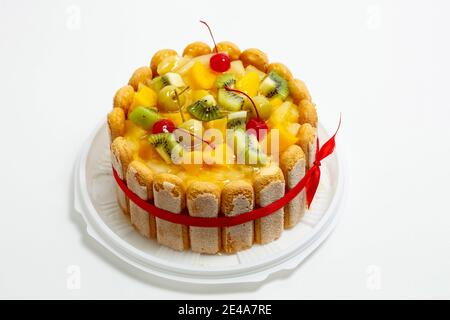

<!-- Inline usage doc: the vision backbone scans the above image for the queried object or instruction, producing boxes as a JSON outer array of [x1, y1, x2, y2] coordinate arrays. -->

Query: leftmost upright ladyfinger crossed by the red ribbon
[[111, 137, 133, 214]]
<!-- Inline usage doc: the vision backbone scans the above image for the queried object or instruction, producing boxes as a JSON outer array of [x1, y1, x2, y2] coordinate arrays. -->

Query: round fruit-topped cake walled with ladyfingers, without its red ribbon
[[107, 22, 318, 254]]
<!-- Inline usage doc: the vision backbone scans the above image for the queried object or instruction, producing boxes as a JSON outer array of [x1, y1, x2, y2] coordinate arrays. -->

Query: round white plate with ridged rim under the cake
[[75, 124, 344, 284]]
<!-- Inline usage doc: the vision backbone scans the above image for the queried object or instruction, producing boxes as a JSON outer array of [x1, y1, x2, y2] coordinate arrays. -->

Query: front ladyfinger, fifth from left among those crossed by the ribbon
[[221, 180, 254, 253]]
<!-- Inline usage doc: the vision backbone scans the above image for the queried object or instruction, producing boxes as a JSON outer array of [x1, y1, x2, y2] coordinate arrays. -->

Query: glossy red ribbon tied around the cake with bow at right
[[112, 119, 341, 227]]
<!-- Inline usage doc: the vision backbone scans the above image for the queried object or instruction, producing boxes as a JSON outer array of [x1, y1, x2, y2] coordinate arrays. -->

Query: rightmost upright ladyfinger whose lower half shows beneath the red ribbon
[[280, 144, 306, 229]]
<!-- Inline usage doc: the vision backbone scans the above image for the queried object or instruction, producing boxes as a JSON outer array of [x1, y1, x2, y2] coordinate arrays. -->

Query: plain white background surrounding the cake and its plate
[[0, 0, 450, 299]]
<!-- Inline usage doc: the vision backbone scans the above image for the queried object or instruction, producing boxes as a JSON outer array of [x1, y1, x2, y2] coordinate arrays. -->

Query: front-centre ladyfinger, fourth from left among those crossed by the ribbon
[[186, 181, 220, 254]]
